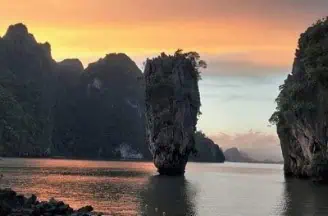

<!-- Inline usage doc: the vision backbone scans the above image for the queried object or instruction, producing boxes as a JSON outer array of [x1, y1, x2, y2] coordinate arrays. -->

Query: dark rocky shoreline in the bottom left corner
[[0, 189, 102, 216]]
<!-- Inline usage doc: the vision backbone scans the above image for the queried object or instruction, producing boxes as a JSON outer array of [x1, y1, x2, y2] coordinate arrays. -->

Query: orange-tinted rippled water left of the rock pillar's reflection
[[1, 159, 155, 215]]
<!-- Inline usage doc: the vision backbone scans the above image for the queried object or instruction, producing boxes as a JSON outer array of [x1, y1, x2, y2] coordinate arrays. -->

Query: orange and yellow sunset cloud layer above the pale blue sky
[[0, 0, 328, 76]]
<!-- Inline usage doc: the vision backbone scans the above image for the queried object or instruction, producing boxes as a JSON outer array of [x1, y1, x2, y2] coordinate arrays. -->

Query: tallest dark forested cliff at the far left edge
[[0, 24, 55, 156]]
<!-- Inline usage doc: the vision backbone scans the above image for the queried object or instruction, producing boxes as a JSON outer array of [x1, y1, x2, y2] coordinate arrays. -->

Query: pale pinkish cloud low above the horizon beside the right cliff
[[210, 130, 282, 161]]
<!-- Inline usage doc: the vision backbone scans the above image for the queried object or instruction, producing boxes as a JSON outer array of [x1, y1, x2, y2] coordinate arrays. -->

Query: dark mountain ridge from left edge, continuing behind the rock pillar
[[0, 24, 224, 162]]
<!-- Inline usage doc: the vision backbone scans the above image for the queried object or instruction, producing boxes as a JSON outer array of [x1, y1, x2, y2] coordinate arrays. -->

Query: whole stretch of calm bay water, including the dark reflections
[[0, 159, 328, 216]]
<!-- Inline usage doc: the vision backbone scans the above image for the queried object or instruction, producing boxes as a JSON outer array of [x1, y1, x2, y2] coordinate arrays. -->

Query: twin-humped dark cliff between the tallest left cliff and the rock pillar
[[54, 54, 151, 159]]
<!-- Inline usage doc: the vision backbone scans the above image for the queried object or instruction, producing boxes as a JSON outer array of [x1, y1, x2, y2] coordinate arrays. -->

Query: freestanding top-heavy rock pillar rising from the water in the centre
[[144, 52, 204, 175]]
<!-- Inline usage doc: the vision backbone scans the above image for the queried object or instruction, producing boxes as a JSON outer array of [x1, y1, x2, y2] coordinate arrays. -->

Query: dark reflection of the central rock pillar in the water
[[140, 176, 196, 216]]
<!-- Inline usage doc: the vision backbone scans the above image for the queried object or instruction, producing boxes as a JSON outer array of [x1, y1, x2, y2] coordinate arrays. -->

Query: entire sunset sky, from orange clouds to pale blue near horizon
[[0, 0, 328, 159]]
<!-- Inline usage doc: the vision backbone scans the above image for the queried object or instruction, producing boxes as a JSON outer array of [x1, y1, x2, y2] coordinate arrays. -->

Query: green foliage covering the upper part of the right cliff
[[269, 18, 328, 124]]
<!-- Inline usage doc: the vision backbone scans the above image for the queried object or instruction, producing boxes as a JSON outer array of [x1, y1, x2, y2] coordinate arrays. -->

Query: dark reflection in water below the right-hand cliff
[[282, 179, 328, 216]]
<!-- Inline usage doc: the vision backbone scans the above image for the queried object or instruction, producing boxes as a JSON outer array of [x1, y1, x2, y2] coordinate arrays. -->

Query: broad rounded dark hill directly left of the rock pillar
[[75, 54, 150, 158]]
